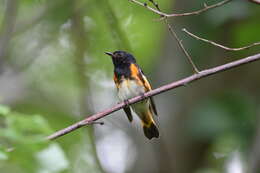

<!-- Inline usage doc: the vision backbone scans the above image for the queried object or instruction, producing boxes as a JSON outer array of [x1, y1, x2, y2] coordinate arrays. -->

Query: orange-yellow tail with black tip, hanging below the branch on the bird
[[142, 111, 159, 139]]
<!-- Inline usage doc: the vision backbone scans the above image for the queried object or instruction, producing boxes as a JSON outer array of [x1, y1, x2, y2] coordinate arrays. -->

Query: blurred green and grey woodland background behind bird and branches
[[0, 0, 260, 173]]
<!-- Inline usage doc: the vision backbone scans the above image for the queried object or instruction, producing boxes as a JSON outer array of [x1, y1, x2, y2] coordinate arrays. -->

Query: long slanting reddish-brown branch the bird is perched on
[[47, 53, 260, 140]]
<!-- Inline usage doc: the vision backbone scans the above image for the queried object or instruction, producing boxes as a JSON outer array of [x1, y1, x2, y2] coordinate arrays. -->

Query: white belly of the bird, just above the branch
[[118, 80, 145, 101]]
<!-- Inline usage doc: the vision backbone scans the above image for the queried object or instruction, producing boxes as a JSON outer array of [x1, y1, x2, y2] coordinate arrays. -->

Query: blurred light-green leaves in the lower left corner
[[0, 105, 52, 172]]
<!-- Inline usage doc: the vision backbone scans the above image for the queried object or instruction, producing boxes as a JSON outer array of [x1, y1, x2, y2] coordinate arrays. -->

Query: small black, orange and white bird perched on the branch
[[105, 51, 159, 139]]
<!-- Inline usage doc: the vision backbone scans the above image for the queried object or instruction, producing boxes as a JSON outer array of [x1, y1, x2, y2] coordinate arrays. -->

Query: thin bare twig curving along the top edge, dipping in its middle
[[129, 0, 232, 18]]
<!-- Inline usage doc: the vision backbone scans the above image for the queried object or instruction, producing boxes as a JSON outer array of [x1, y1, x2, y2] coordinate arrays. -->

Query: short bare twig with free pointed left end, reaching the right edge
[[182, 28, 260, 51]]
